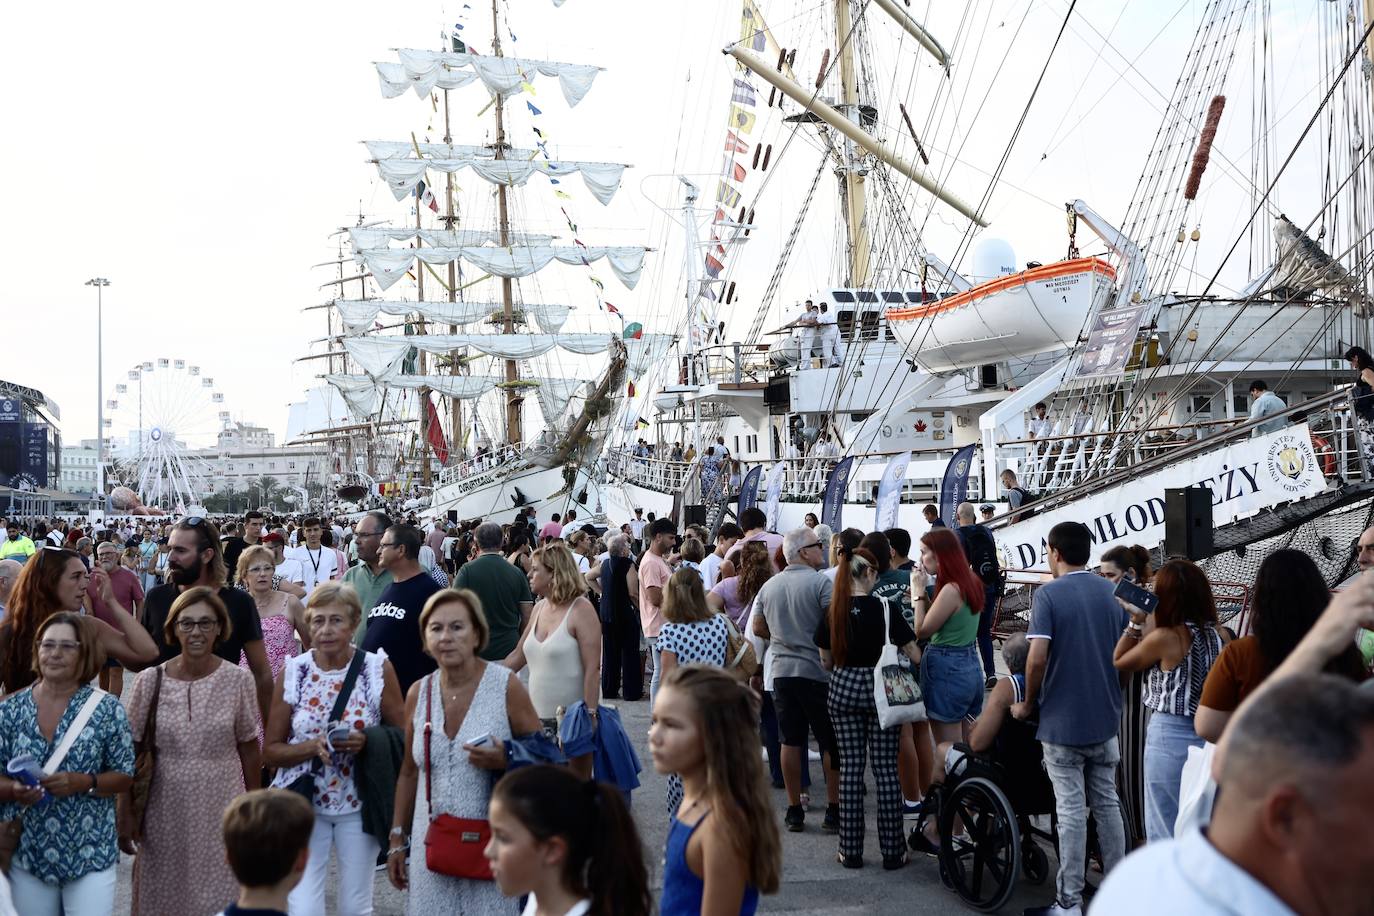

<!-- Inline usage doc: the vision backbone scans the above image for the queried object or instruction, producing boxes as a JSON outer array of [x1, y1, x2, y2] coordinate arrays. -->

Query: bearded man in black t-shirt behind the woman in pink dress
[[144, 516, 272, 721]]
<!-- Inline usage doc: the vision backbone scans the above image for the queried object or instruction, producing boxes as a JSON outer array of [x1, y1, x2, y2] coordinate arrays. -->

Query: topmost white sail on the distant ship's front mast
[[376, 48, 600, 107]]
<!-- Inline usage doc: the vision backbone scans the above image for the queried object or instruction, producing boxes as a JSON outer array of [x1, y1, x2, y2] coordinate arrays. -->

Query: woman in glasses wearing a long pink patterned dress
[[120, 585, 261, 916]]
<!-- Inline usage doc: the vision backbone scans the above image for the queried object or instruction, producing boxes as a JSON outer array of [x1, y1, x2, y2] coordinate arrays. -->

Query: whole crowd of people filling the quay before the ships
[[0, 504, 1374, 916]]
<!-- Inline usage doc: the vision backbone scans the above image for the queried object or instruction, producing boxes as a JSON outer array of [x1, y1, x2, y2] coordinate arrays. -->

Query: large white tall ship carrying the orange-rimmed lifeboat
[[602, 0, 1374, 590]]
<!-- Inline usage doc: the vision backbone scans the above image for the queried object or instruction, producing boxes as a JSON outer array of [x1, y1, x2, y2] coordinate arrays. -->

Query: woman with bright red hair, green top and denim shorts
[[911, 527, 984, 743]]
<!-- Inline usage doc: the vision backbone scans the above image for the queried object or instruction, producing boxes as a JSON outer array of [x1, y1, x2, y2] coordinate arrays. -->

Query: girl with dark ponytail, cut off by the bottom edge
[[486, 765, 654, 916]]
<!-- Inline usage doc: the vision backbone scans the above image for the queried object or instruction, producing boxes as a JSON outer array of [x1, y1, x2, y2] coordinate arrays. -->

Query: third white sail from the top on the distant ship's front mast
[[356, 244, 649, 290]]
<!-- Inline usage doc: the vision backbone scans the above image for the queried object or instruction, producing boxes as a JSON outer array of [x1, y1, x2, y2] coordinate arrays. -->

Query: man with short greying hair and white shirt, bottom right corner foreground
[[1092, 672, 1374, 916]]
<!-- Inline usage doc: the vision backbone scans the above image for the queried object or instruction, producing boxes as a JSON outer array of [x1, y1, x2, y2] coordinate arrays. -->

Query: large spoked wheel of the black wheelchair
[[940, 776, 1021, 913]]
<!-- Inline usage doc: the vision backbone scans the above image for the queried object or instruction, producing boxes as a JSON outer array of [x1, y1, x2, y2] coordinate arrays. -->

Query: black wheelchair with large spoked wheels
[[907, 720, 1058, 913]]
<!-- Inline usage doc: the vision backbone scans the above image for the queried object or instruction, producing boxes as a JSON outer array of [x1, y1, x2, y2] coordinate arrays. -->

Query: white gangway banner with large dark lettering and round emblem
[[1000, 423, 1326, 570]]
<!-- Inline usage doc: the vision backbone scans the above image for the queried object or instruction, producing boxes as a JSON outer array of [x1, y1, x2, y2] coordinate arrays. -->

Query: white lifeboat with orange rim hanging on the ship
[[888, 258, 1116, 372]]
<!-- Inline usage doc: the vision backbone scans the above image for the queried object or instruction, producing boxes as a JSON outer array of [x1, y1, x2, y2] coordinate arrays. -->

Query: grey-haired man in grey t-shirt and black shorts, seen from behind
[[754, 527, 840, 834]]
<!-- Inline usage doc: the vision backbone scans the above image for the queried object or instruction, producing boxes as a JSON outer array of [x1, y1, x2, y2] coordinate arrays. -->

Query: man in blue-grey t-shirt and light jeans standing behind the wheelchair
[[1011, 522, 1134, 916]]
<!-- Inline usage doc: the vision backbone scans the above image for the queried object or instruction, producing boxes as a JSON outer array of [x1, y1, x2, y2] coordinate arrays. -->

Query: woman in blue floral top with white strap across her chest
[[0, 612, 133, 916]]
